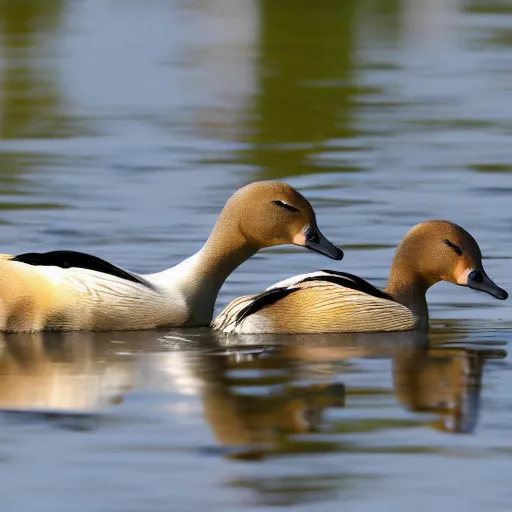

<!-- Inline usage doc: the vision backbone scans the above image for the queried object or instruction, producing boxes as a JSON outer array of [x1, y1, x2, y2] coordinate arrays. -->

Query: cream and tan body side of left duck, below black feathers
[[0, 255, 186, 331]]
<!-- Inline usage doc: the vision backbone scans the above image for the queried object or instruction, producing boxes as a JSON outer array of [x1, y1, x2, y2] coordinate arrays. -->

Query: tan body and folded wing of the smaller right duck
[[213, 270, 416, 333]]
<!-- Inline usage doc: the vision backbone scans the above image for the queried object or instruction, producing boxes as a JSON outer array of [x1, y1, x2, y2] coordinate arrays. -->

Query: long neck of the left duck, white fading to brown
[[158, 219, 260, 326]]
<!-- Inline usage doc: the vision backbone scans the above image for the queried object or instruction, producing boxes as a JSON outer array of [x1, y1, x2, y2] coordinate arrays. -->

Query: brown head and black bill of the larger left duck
[[223, 181, 343, 260]]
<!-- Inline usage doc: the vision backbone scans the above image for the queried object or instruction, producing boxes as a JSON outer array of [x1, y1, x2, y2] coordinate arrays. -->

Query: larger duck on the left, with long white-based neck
[[0, 180, 343, 332]]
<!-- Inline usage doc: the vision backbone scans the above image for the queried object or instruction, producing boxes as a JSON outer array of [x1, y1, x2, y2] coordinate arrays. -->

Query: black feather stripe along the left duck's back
[[11, 251, 148, 286]]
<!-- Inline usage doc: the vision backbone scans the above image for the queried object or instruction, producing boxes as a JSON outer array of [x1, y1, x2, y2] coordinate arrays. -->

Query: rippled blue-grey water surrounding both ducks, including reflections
[[0, 0, 512, 512]]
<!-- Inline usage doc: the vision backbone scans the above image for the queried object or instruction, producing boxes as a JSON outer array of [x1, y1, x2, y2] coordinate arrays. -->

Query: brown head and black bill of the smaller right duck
[[397, 220, 508, 300]]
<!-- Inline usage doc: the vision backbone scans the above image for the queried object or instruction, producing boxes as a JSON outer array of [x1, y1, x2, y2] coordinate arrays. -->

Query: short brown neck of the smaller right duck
[[384, 261, 434, 328]]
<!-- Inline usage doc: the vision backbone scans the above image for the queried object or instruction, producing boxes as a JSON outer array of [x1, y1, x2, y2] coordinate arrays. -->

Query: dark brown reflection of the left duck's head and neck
[[194, 349, 345, 458]]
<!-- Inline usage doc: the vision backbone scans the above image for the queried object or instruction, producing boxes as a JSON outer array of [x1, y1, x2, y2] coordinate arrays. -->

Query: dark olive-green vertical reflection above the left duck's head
[[247, 0, 361, 179]]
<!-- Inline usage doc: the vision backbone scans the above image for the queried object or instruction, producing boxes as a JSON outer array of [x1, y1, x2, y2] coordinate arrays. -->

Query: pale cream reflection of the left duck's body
[[0, 329, 216, 413]]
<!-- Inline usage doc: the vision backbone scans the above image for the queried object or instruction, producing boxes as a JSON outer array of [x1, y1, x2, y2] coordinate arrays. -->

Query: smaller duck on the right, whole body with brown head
[[212, 220, 508, 334]]
